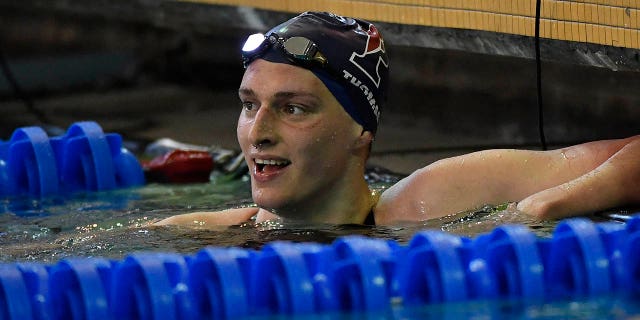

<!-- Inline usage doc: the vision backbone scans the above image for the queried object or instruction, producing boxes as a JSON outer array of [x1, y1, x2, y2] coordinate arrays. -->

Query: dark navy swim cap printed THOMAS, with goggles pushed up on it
[[242, 12, 389, 134]]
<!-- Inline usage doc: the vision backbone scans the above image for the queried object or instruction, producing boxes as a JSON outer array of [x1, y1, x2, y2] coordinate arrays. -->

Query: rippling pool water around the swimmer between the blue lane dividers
[[0, 171, 555, 263]]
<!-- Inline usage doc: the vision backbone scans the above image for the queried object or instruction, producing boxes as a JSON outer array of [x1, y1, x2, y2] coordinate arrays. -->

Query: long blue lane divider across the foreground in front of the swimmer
[[0, 216, 640, 319]]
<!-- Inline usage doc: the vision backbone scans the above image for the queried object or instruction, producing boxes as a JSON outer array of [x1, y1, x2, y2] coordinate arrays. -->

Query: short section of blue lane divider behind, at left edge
[[0, 121, 144, 197]]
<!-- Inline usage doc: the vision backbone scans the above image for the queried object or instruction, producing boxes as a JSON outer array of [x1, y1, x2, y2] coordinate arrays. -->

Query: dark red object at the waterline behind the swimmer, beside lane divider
[[142, 150, 214, 183]]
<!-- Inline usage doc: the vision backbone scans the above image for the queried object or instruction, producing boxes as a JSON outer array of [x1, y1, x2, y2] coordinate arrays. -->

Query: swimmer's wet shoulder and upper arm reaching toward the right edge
[[375, 136, 640, 224]]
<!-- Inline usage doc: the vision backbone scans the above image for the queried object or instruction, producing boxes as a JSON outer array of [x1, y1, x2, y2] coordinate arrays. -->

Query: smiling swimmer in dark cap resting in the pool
[[157, 12, 640, 226]]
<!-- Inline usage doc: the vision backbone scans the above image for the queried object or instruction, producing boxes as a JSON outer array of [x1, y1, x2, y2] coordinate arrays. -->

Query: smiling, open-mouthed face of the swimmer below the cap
[[237, 59, 368, 218]]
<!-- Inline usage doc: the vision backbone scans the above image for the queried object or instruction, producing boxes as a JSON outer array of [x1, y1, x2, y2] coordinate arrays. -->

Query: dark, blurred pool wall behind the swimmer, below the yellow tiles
[[0, 0, 640, 172]]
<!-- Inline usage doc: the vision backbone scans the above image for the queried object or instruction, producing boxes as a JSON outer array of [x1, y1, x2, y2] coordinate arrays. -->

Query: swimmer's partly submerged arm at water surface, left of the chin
[[154, 207, 259, 227]]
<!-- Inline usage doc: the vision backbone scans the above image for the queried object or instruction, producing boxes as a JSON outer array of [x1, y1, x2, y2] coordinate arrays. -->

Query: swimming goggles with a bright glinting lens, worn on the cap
[[242, 33, 327, 68]]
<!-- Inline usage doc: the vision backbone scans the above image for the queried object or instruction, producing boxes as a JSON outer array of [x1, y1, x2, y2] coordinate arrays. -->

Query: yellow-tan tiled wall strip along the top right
[[182, 0, 640, 49]]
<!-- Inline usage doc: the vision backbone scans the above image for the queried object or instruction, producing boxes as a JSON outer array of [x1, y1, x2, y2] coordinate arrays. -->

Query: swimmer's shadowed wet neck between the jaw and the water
[[256, 179, 377, 224]]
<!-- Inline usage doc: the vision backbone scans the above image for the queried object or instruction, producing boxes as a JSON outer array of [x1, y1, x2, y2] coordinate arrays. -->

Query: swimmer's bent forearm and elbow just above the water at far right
[[517, 136, 640, 219]]
